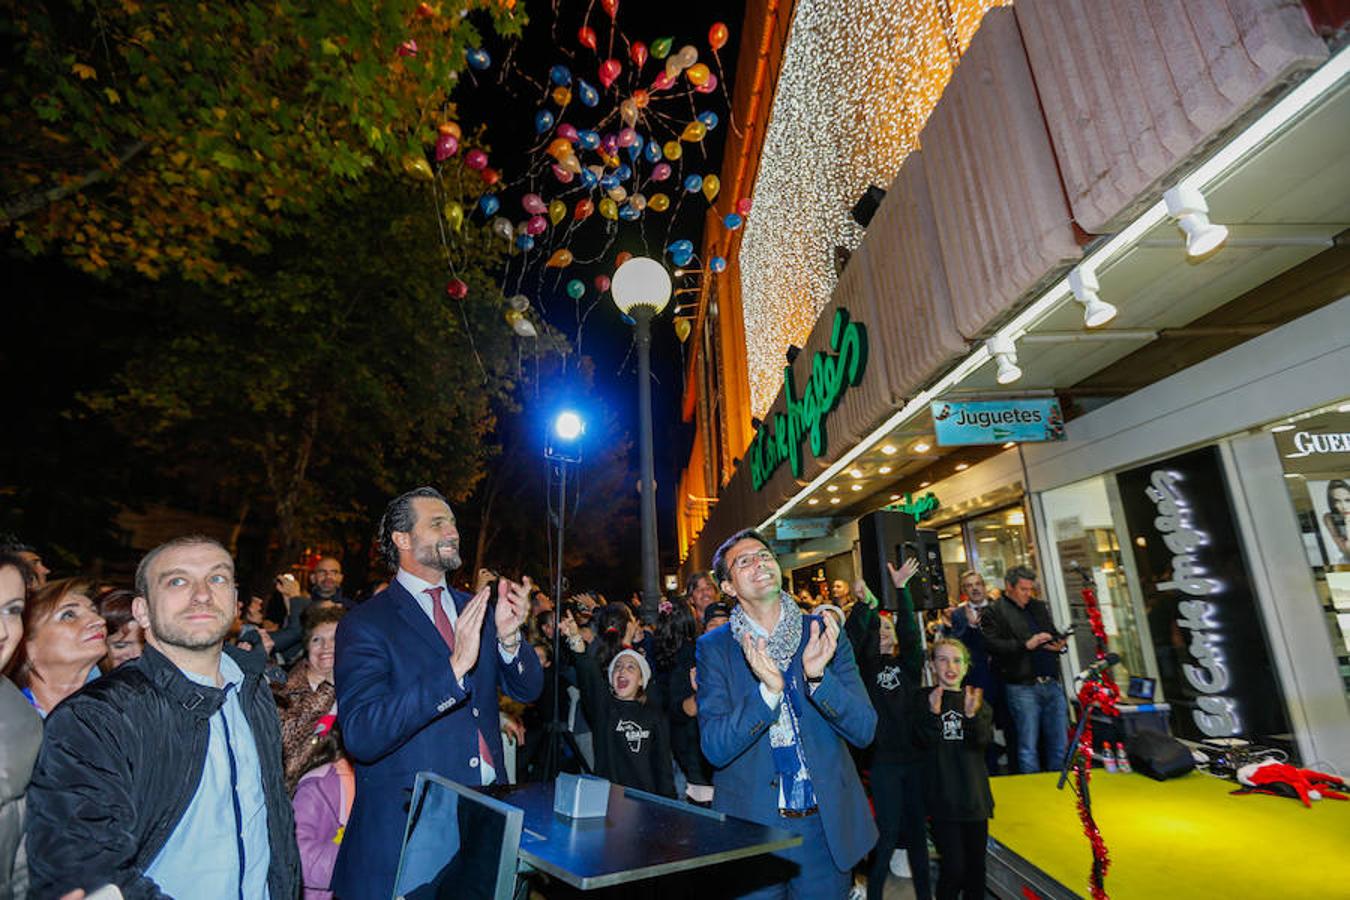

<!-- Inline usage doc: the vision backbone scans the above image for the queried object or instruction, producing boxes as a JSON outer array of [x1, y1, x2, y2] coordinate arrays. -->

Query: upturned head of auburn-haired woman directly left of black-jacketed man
[[18, 578, 108, 718]]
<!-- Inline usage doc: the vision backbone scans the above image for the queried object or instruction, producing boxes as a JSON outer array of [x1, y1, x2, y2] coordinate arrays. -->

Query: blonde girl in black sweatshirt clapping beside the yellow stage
[[915, 638, 994, 900]]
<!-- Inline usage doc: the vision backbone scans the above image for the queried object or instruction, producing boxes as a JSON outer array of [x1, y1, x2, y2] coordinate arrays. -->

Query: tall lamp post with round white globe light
[[610, 256, 671, 622]]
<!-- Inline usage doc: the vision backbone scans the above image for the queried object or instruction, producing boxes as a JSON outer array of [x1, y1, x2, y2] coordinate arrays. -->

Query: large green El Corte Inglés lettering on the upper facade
[[749, 308, 867, 491]]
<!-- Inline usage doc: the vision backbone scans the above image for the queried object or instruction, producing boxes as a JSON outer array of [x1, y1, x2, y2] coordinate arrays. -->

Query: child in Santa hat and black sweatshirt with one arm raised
[[560, 606, 675, 797]]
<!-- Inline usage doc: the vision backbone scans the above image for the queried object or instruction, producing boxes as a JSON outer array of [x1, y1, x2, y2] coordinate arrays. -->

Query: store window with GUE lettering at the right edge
[[1270, 403, 1350, 695]]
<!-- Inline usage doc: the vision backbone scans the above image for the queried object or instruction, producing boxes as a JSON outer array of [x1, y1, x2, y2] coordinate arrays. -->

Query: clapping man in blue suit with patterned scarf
[[697, 529, 876, 900]]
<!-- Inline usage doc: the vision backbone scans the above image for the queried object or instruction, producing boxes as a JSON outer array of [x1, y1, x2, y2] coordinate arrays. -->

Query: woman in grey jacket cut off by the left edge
[[0, 553, 42, 897]]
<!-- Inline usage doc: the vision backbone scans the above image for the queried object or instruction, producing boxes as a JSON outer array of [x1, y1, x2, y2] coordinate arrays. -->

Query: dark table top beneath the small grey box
[[485, 781, 802, 891]]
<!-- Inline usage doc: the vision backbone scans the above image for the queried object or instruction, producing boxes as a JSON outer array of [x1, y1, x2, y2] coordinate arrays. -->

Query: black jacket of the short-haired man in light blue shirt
[[27, 645, 301, 900]]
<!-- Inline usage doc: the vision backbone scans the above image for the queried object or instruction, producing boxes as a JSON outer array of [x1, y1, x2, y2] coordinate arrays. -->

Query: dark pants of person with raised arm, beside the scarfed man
[[867, 762, 932, 900]]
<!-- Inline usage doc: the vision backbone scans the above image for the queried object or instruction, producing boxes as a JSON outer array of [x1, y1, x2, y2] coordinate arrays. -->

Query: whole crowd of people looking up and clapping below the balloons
[[0, 487, 1067, 900]]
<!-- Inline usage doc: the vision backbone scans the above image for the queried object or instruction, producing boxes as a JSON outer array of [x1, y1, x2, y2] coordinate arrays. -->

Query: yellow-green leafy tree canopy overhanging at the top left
[[0, 0, 525, 282]]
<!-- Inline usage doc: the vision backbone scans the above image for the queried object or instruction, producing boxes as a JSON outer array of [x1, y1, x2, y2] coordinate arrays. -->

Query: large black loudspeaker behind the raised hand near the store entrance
[[857, 510, 948, 613]]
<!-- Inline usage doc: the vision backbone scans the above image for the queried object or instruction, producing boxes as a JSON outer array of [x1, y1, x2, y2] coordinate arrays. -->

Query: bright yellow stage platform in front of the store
[[988, 769, 1350, 900]]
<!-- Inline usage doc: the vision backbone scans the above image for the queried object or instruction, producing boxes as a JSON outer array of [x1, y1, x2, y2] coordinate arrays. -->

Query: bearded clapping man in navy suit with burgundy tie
[[332, 487, 544, 900]]
